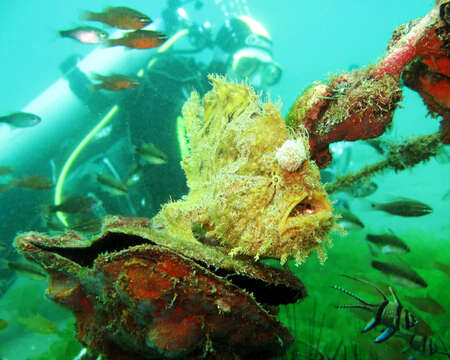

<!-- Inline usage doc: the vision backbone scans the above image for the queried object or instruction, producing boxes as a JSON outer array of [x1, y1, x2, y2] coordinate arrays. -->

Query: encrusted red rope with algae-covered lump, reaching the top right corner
[[286, 4, 450, 168]]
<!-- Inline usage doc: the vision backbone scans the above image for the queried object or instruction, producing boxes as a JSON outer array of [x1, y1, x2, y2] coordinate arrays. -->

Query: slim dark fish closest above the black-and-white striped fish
[[371, 260, 428, 289]]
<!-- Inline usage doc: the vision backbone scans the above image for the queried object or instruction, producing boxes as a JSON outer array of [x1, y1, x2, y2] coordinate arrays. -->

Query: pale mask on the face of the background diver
[[232, 48, 282, 88]]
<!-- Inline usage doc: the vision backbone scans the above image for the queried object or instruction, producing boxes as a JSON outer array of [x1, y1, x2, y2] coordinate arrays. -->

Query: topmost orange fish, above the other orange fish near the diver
[[82, 6, 152, 30]]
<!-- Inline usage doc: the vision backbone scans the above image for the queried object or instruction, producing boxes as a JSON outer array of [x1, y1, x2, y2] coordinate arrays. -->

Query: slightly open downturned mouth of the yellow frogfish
[[278, 192, 333, 236]]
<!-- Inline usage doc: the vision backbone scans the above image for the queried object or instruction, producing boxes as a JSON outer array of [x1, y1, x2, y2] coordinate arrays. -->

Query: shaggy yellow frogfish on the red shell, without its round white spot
[[154, 77, 334, 263]]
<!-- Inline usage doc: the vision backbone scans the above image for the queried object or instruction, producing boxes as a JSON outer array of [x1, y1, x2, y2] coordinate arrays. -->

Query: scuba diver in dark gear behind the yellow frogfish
[[56, 0, 282, 217]]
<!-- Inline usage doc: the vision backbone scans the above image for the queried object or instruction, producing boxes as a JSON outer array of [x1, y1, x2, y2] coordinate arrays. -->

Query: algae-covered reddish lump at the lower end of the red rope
[[286, 67, 402, 168]]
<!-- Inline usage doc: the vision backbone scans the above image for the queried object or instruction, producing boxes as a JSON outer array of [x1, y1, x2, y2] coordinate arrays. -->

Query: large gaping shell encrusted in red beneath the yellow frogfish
[[15, 216, 306, 360]]
